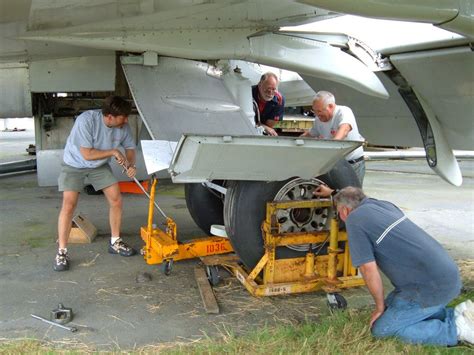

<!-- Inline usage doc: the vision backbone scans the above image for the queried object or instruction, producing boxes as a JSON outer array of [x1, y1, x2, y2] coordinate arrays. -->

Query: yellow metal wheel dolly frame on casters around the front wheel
[[201, 200, 364, 308]]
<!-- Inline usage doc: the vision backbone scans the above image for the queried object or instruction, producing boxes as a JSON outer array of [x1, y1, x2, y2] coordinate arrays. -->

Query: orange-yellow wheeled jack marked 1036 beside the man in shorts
[[140, 178, 233, 275]]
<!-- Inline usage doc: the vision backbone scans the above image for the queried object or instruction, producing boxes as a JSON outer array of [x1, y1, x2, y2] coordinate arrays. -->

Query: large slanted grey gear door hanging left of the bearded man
[[122, 58, 256, 141]]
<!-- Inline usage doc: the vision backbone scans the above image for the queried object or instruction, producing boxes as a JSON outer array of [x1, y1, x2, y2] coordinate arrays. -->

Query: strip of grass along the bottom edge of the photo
[[0, 300, 474, 355]]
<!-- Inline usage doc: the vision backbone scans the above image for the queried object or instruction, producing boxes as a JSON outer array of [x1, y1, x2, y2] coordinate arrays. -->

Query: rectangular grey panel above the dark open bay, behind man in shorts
[[30, 55, 115, 92]]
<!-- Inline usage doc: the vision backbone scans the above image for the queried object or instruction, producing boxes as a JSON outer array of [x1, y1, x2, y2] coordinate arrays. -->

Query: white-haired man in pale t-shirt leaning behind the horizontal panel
[[301, 91, 365, 186]]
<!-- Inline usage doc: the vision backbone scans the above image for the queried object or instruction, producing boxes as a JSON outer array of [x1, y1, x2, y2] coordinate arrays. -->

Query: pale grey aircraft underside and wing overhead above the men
[[0, 0, 474, 188]]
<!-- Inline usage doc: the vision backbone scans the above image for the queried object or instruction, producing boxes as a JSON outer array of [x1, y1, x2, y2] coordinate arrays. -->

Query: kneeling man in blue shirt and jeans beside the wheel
[[315, 186, 474, 345]]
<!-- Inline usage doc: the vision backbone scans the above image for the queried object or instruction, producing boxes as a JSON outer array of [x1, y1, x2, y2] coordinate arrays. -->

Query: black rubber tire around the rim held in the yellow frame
[[224, 160, 360, 269]]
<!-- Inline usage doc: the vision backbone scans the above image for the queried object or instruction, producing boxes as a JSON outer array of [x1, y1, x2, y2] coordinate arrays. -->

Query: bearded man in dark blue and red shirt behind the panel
[[252, 72, 285, 136]]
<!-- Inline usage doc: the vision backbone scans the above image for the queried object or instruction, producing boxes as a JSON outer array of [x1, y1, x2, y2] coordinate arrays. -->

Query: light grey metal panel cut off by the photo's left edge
[[0, 63, 33, 118]]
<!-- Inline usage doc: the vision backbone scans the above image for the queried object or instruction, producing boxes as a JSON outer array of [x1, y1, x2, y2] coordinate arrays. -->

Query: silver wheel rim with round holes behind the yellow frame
[[274, 178, 329, 251]]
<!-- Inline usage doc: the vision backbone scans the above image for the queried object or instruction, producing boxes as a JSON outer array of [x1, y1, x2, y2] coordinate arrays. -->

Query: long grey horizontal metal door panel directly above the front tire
[[169, 135, 362, 183]]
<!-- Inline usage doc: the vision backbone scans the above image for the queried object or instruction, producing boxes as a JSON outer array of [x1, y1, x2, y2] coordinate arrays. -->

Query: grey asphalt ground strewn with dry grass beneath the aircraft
[[0, 132, 474, 350]]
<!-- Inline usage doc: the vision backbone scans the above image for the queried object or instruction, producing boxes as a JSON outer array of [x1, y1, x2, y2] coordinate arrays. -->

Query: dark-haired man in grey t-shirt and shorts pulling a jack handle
[[53, 96, 136, 271]]
